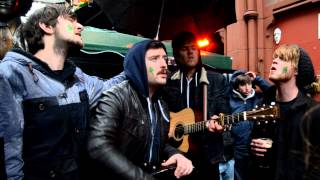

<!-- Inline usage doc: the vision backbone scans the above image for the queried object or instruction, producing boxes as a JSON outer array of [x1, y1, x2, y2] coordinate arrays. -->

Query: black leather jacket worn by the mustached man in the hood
[[88, 81, 179, 179]]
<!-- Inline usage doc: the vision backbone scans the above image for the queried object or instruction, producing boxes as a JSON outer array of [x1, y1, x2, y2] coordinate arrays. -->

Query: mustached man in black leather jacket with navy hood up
[[88, 40, 193, 179]]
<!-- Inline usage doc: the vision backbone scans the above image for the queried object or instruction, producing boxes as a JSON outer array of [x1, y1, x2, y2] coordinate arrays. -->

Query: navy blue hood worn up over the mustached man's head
[[124, 40, 152, 97]]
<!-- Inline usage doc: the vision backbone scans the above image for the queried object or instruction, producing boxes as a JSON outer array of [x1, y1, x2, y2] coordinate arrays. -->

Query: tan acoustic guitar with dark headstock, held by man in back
[[169, 105, 280, 152]]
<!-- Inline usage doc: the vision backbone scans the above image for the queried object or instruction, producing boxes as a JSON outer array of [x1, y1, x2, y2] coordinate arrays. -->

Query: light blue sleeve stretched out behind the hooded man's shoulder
[[76, 68, 126, 108]]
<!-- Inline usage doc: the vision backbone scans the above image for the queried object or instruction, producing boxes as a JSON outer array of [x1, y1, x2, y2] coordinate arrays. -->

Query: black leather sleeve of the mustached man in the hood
[[88, 91, 153, 180]]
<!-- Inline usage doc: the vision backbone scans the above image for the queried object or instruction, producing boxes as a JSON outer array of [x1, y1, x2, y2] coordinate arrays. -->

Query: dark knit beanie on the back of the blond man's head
[[296, 48, 316, 90]]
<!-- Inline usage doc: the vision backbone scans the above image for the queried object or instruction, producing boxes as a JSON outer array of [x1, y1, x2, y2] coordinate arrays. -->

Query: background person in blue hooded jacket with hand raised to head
[[224, 70, 270, 180]]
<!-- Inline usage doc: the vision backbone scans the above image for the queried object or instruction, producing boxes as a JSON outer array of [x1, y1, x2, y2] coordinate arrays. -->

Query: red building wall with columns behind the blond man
[[222, 0, 320, 77]]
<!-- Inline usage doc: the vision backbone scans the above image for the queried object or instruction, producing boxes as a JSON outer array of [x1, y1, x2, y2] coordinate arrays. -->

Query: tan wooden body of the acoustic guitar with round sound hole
[[169, 108, 195, 152]]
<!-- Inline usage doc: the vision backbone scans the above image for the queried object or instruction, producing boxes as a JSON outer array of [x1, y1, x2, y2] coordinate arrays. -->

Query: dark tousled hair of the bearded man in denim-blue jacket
[[19, 4, 76, 54]]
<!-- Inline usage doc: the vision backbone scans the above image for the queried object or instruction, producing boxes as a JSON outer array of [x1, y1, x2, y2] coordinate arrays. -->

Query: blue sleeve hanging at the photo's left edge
[[0, 75, 23, 180]]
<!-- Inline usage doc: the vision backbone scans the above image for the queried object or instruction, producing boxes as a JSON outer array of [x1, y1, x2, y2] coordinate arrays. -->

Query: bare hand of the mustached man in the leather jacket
[[161, 154, 193, 178]]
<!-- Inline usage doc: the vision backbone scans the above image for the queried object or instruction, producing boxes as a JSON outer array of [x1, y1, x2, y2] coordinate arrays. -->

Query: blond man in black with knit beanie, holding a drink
[[251, 45, 319, 180]]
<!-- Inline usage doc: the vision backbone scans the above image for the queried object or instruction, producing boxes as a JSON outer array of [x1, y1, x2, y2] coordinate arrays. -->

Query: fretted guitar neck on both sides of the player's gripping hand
[[183, 112, 247, 134]]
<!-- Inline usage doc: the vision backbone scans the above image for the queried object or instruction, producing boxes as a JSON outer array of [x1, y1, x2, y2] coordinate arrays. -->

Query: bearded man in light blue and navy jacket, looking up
[[0, 5, 124, 179]]
